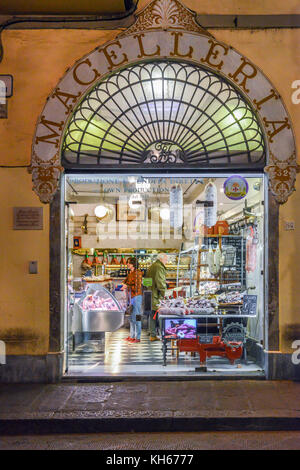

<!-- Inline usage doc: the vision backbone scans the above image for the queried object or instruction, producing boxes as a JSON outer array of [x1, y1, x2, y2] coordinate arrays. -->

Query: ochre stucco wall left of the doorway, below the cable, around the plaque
[[0, 168, 49, 354]]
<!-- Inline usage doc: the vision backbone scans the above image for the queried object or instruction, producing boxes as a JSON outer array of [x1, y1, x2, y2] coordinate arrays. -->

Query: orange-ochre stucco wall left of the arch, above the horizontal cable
[[0, 30, 117, 165]]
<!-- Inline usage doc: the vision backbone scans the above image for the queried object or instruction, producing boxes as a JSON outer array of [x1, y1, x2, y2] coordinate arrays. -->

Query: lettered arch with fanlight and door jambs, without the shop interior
[[31, 0, 297, 380]]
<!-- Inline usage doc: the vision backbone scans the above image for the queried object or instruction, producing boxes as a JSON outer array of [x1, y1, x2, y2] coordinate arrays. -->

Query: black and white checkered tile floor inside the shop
[[67, 328, 262, 376]]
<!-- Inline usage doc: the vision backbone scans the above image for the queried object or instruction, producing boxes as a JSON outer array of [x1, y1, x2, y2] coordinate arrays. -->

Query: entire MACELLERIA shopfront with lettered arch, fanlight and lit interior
[[31, 2, 297, 379]]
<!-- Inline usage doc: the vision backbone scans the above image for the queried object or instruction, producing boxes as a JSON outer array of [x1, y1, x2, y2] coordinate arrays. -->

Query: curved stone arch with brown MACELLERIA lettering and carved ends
[[30, 0, 298, 203]]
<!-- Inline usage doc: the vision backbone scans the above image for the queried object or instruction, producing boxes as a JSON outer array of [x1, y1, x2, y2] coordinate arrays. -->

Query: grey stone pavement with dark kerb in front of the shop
[[0, 380, 300, 435]]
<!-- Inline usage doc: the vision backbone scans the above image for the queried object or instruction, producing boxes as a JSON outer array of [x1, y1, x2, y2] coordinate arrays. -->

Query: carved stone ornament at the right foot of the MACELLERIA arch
[[265, 152, 300, 204]]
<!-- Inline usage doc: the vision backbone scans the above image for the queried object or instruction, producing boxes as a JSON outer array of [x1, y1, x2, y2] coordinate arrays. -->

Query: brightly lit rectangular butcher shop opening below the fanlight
[[65, 172, 266, 378]]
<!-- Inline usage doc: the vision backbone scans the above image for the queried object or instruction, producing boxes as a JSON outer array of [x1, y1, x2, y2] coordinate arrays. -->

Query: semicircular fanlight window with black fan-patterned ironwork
[[62, 61, 265, 168]]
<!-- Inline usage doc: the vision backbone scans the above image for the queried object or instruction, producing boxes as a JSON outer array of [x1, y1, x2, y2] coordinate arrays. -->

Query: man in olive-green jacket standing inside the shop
[[146, 253, 168, 341]]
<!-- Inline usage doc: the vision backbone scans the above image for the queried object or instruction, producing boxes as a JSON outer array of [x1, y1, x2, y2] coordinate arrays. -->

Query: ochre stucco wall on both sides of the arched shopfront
[[0, 24, 300, 354]]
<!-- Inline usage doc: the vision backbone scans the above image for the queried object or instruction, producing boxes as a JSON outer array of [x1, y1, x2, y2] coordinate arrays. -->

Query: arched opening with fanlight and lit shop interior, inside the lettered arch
[[61, 60, 267, 378]]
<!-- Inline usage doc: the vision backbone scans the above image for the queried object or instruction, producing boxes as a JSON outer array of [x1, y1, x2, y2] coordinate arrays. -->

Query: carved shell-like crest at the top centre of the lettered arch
[[120, 0, 212, 36]]
